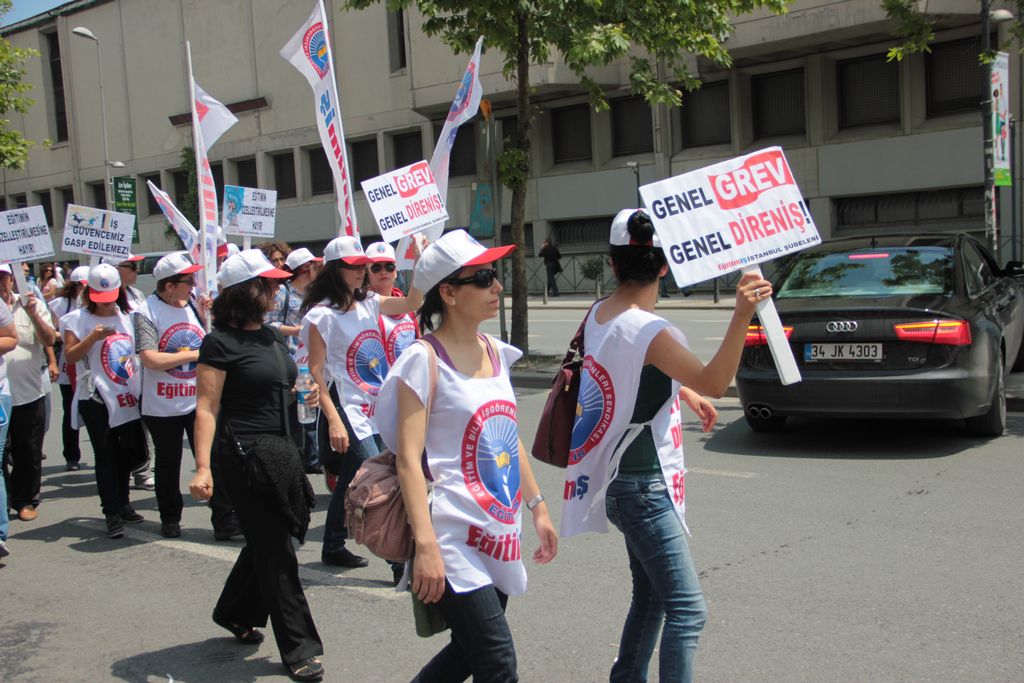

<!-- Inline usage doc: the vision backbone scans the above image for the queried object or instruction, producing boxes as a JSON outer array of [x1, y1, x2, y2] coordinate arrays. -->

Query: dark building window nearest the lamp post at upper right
[[925, 38, 998, 117]]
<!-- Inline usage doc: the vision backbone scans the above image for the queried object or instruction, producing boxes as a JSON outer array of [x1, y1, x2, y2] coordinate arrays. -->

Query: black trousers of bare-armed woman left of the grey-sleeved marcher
[[78, 398, 145, 515]]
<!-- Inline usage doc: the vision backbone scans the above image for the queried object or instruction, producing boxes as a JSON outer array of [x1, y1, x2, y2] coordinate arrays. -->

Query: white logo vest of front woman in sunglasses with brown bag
[[377, 340, 526, 595]]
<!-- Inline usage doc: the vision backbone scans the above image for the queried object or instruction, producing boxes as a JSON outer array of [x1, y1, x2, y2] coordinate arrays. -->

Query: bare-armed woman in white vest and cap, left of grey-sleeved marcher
[[61, 263, 145, 539]]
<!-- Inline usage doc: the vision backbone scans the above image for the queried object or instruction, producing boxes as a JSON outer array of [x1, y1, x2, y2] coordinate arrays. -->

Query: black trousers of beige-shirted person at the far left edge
[[3, 396, 46, 510]]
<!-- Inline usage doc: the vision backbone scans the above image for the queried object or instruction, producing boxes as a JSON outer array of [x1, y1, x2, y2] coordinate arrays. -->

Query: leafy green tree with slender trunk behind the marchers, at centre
[[346, 0, 787, 351]]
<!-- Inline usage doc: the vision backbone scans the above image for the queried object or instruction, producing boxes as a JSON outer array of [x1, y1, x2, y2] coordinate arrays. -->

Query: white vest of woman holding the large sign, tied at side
[[560, 303, 686, 537]]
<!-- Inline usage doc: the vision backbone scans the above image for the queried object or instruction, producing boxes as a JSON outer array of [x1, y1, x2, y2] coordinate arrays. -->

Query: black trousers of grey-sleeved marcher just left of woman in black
[[142, 411, 238, 531]]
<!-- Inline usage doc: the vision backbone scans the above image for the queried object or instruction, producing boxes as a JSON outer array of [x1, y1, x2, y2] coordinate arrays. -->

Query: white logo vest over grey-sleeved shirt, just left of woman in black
[[137, 294, 206, 418]]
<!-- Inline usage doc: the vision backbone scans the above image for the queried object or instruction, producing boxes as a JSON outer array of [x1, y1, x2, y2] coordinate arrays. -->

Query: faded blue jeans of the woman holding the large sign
[[605, 473, 708, 683]]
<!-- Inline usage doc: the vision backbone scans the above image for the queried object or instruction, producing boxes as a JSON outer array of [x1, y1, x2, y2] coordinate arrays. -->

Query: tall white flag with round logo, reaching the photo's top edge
[[281, 0, 359, 237]]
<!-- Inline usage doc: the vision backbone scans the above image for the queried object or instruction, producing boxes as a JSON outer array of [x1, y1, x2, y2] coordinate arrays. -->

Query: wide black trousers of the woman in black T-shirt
[[213, 462, 324, 665]]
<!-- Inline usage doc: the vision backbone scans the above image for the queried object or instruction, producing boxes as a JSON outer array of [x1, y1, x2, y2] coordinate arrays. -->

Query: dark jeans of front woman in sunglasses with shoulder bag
[[413, 582, 519, 683]]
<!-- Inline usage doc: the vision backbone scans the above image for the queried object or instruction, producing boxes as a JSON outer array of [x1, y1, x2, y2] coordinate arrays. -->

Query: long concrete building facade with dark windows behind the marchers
[[0, 0, 1021, 290]]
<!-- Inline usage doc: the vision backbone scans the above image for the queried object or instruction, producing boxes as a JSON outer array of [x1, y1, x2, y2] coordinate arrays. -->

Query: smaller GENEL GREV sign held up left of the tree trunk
[[362, 161, 447, 242]]
